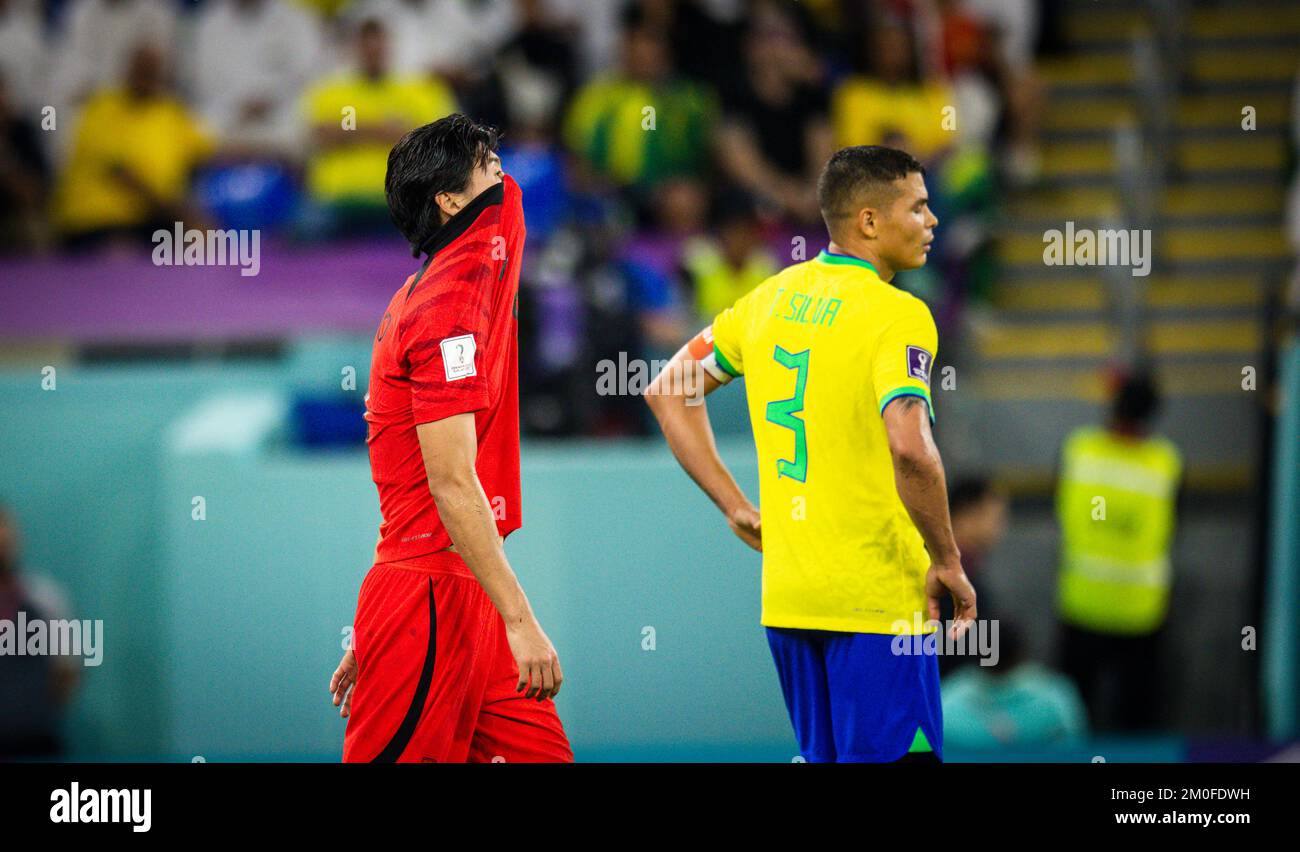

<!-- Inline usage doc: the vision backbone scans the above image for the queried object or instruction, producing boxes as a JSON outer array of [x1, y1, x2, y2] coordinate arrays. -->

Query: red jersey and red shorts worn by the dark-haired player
[[343, 177, 573, 762]]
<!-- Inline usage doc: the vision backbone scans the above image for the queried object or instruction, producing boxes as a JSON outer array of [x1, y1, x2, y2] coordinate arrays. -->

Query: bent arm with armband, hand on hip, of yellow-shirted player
[[645, 346, 763, 550]]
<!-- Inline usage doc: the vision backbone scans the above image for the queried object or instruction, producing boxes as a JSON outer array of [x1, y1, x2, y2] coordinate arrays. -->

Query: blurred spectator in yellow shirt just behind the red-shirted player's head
[[304, 18, 456, 233]]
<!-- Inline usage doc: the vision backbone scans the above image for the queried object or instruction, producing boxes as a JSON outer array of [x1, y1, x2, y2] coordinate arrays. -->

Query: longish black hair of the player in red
[[384, 113, 501, 258]]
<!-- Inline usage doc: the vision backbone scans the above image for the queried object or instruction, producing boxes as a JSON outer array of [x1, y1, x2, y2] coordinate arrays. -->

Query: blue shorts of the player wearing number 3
[[767, 627, 944, 764]]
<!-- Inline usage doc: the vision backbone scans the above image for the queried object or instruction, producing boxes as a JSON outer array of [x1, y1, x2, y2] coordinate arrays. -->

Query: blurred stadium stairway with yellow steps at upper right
[[950, 0, 1300, 493]]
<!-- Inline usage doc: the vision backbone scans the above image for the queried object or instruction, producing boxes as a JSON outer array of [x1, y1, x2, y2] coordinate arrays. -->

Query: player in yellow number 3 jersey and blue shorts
[[646, 146, 976, 762]]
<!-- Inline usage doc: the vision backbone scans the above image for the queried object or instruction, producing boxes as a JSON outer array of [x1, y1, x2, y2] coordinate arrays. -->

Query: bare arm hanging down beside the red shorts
[[416, 414, 563, 701]]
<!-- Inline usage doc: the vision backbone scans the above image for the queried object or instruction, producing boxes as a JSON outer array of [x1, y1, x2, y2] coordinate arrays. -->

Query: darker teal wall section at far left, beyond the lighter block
[[0, 364, 280, 756]]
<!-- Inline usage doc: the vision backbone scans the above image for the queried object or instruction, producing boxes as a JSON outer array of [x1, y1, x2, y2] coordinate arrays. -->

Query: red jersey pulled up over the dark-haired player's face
[[365, 176, 525, 562]]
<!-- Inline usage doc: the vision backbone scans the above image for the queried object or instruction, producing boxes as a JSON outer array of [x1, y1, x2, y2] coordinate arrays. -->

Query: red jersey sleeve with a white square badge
[[400, 251, 494, 424]]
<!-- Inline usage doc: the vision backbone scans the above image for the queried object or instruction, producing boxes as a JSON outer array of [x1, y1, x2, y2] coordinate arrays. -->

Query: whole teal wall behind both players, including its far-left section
[[0, 356, 796, 760]]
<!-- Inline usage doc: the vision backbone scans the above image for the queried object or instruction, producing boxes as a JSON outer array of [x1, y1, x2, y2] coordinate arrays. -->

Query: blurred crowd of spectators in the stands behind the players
[[0, 0, 1053, 434]]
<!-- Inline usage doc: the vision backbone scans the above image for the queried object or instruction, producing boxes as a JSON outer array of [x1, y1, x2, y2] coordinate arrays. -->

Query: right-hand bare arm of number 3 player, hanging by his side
[[883, 397, 976, 637]]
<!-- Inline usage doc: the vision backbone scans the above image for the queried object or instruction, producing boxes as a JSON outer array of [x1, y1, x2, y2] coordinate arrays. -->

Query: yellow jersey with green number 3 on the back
[[712, 251, 939, 633]]
